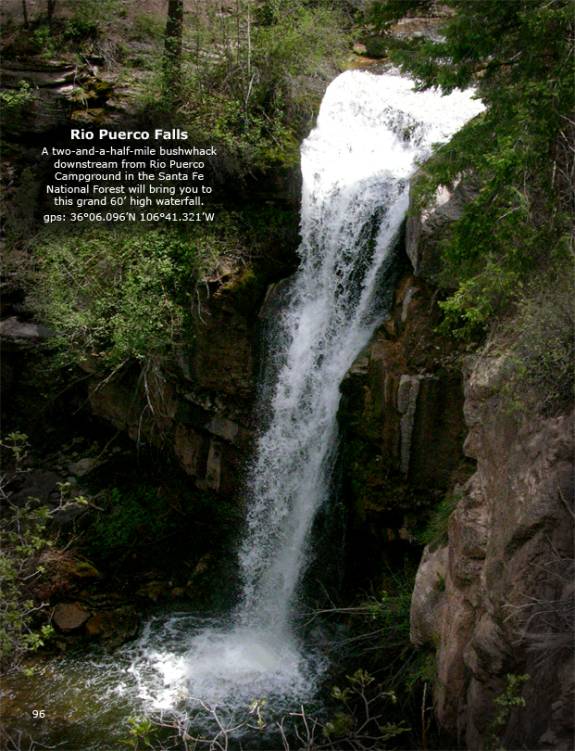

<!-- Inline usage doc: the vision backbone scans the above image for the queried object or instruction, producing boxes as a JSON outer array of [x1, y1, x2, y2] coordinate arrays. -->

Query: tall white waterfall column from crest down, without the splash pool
[[236, 72, 481, 634]]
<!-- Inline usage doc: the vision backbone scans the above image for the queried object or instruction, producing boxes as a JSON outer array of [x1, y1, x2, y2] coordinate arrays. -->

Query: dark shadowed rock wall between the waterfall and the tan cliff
[[340, 269, 469, 581]]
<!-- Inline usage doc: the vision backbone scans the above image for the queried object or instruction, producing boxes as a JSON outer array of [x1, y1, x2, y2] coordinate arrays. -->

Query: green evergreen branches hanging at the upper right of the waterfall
[[371, 0, 574, 339]]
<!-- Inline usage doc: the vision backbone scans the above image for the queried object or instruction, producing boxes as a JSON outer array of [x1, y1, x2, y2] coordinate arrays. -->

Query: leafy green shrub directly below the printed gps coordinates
[[30, 227, 221, 369]]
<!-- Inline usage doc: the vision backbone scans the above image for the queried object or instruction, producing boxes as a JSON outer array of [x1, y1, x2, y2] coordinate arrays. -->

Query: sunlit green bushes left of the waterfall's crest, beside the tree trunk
[[145, 0, 352, 174]]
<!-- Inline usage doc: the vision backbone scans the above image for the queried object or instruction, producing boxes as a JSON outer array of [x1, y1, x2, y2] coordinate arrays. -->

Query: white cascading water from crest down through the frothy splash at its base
[[126, 71, 483, 708]]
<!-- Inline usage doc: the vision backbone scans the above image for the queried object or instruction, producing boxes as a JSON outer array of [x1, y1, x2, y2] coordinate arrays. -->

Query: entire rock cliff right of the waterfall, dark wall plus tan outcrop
[[342, 178, 574, 749]]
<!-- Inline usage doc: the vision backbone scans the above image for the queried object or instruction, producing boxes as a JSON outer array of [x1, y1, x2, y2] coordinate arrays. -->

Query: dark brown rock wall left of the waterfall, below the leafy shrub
[[86, 256, 293, 496]]
